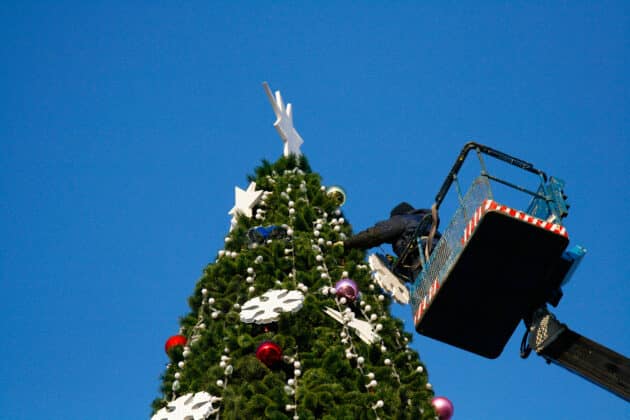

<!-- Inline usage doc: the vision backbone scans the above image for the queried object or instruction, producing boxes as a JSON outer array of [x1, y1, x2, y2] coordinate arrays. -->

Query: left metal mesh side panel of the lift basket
[[411, 176, 492, 308]]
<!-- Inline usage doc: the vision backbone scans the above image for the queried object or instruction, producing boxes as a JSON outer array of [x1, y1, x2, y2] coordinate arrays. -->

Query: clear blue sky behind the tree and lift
[[0, 1, 630, 420]]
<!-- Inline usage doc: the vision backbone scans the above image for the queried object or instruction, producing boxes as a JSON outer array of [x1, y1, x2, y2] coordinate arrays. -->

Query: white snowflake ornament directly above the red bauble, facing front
[[241, 289, 304, 324]]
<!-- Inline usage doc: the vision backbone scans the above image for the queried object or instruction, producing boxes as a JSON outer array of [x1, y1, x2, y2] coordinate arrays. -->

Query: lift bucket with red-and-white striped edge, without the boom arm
[[411, 143, 579, 358]]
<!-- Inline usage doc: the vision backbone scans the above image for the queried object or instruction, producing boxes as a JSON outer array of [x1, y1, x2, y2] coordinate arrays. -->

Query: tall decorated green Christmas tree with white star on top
[[152, 85, 436, 420]]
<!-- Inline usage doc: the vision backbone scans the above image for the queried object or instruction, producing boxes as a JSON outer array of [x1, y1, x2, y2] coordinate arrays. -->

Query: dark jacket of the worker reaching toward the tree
[[343, 209, 431, 257]]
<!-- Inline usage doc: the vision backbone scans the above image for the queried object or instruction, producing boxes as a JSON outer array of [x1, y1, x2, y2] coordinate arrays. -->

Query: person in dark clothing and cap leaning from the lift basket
[[343, 202, 441, 282]]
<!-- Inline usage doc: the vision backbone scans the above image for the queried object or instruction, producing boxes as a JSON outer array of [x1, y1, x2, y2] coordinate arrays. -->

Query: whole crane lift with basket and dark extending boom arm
[[410, 142, 630, 401]]
